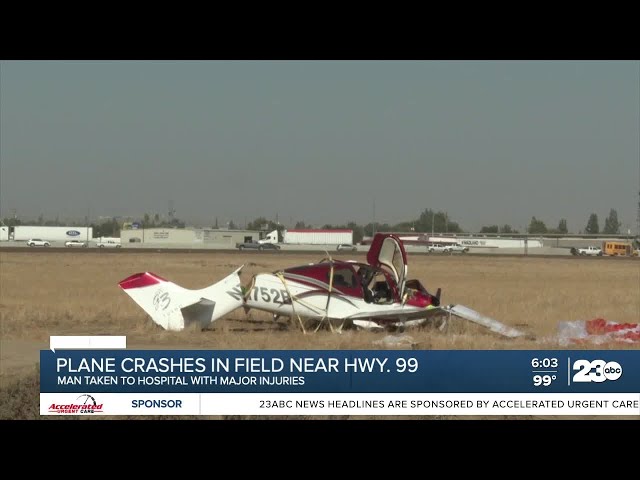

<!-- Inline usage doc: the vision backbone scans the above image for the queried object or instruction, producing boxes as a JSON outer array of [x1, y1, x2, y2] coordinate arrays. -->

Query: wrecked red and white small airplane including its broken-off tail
[[119, 233, 525, 337]]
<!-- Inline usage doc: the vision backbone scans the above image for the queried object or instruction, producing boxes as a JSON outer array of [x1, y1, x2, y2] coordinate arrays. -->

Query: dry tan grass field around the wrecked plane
[[0, 250, 640, 418]]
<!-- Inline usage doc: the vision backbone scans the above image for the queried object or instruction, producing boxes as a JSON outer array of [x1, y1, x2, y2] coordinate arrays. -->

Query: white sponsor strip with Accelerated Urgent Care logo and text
[[40, 393, 640, 419]]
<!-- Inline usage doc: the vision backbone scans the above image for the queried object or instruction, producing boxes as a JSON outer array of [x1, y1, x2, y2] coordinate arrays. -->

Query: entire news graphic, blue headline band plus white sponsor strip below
[[40, 349, 640, 418]]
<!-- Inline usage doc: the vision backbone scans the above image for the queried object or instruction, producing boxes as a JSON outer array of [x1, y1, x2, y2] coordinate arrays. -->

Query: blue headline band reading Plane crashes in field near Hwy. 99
[[40, 349, 640, 395]]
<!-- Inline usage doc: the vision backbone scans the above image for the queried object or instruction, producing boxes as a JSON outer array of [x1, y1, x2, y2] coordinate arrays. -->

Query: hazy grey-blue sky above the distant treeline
[[0, 61, 640, 231]]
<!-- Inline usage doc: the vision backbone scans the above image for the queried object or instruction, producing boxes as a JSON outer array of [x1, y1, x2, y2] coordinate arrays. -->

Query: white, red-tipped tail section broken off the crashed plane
[[118, 265, 244, 331]]
